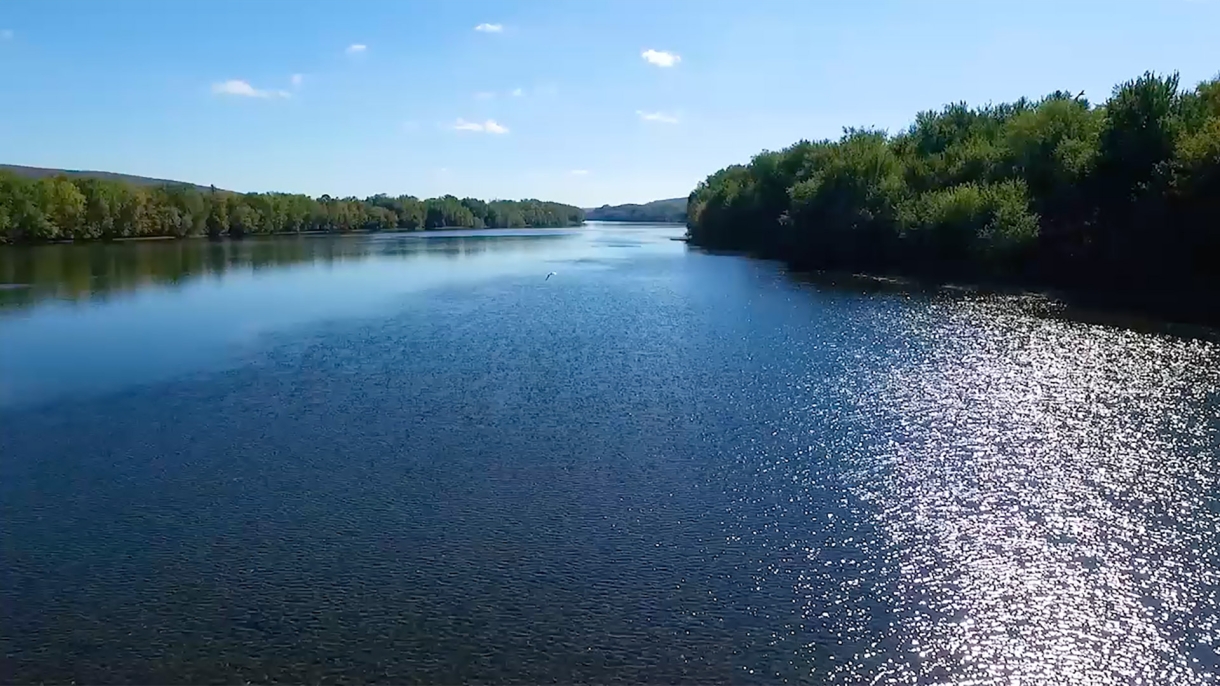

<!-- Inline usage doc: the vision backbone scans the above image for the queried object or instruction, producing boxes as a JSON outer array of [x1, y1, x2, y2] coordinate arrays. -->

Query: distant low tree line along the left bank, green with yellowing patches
[[0, 171, 584, 243]]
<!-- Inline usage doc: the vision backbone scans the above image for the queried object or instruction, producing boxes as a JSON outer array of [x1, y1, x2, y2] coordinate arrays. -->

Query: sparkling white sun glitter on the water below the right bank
[[836, 303, 1220, 684]]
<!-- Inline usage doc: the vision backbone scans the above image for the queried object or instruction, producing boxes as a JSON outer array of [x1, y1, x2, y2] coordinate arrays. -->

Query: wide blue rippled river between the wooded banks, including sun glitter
[[0, 226, 1220, 685]]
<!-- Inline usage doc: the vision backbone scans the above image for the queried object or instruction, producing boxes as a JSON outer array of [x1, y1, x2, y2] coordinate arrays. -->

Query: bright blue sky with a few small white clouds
[[0, 0, 1220, 206]]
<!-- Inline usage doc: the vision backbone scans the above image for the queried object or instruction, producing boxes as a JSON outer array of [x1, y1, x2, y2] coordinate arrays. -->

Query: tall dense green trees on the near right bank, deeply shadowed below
[[687, 73, 1220, 321]]
